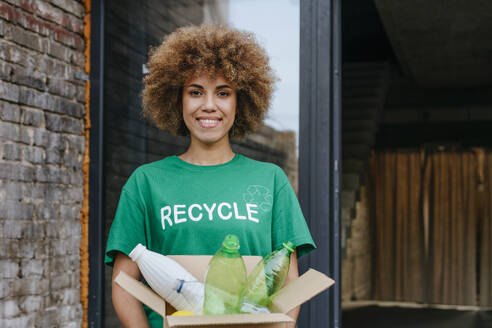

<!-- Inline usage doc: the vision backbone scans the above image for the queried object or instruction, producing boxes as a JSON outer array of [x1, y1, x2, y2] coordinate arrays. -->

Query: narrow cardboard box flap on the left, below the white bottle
[[114, 271, 166, 318]]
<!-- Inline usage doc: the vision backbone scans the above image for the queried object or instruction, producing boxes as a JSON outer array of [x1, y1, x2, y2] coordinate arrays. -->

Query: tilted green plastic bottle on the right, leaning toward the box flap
[[240, 241, 295, 313]]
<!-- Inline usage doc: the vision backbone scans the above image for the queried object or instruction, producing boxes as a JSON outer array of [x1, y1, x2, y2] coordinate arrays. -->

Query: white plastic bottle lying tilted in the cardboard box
[[129, 244, 204, 314]]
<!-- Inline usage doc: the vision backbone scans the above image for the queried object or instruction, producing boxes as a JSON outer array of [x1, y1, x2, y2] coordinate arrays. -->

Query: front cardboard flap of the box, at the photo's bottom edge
[[167, 313, 294, 328]]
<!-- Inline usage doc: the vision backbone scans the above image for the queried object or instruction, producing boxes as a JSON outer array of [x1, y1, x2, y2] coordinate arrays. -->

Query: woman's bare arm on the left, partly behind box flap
[[111, 252, 149, 328]]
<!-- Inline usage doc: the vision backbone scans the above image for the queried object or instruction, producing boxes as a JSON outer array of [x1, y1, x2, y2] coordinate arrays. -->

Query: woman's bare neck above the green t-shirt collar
[[178, 140, 235, 165]]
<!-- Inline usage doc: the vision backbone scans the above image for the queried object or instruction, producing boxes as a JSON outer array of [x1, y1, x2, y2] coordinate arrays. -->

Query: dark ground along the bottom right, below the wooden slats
[[342, 305, 492, 328]]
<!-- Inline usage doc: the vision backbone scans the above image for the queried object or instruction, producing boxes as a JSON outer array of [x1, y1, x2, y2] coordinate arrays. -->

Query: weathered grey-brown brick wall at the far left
[[0, 0, 85, 327]]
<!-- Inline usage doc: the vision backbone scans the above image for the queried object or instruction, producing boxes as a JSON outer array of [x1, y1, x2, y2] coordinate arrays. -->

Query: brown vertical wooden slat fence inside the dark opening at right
[[369, 149, 492, 306]]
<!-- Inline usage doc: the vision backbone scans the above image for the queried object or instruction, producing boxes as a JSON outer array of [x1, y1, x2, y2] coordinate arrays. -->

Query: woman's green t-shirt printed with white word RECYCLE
[[105, 154, 315, 327]]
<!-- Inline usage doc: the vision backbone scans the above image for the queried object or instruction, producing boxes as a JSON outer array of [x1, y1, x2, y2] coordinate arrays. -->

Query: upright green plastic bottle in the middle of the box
[[203, 235, 246, 314]]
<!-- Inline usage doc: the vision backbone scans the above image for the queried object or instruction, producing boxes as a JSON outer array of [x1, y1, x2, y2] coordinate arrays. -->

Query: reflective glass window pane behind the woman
[[104, 0, 299, 327]]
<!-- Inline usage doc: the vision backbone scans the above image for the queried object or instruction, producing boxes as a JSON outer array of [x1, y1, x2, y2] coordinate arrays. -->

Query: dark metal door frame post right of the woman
[[299, 0, 342, 328]]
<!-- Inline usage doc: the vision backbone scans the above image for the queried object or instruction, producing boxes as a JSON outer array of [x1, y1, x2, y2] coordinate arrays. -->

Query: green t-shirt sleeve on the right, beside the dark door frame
[[272, 168, 316, 257]]
